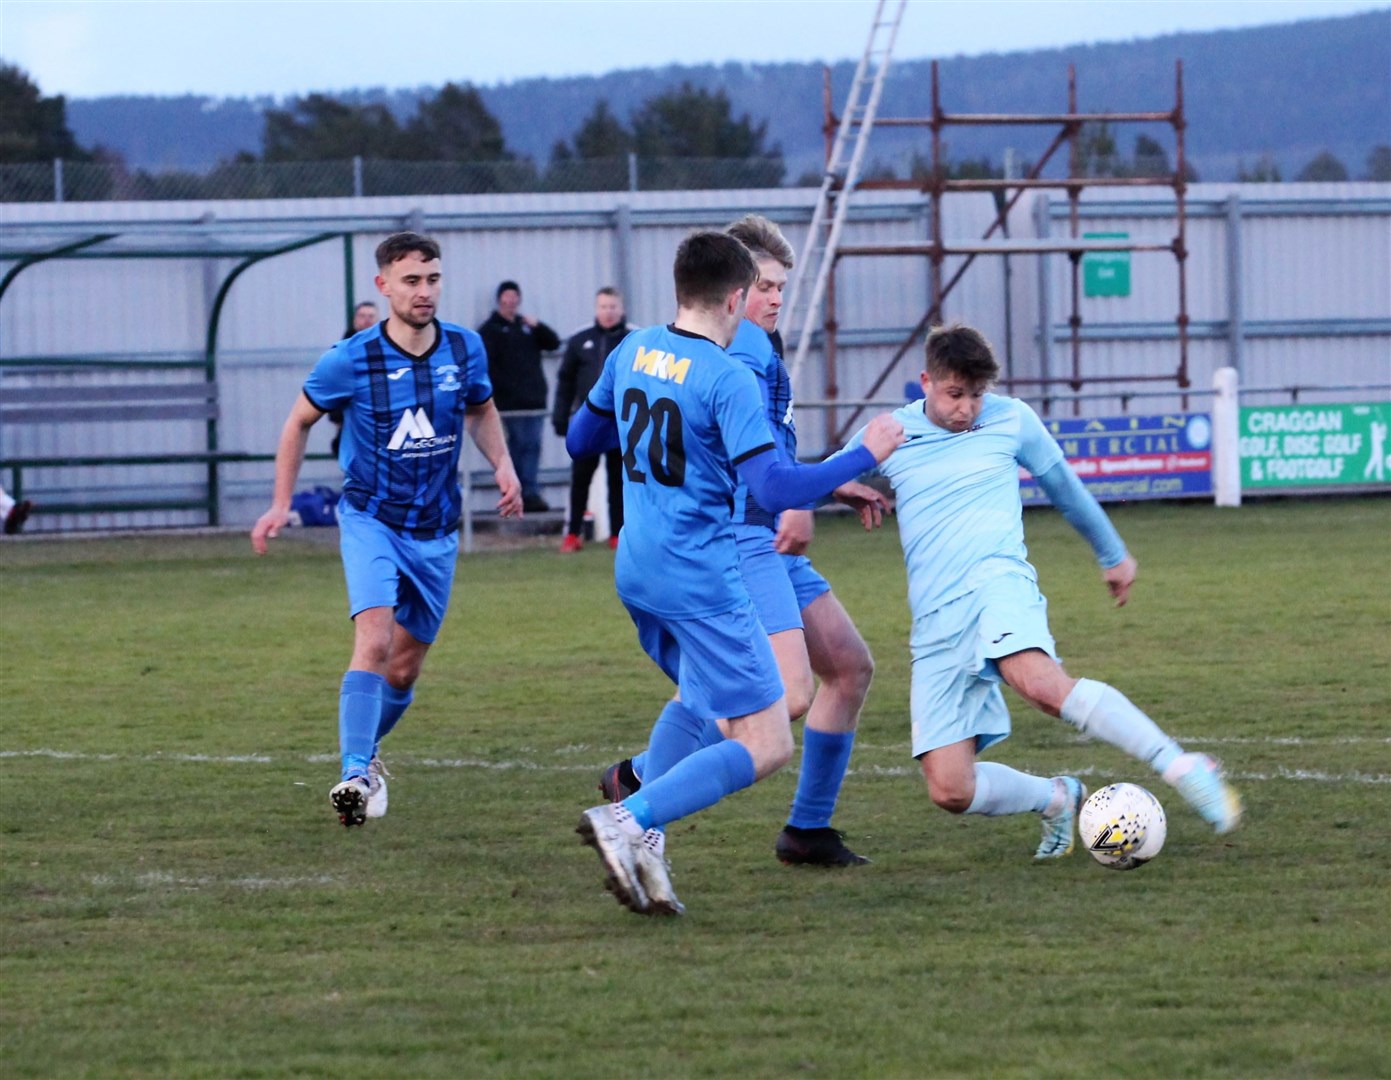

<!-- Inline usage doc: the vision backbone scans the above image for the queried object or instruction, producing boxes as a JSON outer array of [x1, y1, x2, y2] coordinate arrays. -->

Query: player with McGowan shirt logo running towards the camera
[[252, 232, 522, 825]]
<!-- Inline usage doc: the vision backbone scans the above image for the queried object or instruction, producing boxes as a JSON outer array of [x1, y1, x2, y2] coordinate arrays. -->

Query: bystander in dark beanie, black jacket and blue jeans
[[479, 281, 561, 514]]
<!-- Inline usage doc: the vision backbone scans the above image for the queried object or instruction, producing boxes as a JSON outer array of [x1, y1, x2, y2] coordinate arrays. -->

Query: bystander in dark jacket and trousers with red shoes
[[551, 285, 633, 555]]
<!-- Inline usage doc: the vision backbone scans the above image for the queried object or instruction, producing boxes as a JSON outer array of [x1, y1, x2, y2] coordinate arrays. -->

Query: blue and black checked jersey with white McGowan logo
[[305, 320, 492, 540]]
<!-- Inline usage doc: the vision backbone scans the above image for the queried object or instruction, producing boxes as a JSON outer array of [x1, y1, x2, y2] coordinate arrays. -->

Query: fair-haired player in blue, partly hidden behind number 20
[[600, 214, 887, 867]]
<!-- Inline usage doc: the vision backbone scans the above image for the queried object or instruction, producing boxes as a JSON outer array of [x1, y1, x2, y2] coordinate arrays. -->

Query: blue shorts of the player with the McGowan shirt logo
[[338, 500, 459, 644]]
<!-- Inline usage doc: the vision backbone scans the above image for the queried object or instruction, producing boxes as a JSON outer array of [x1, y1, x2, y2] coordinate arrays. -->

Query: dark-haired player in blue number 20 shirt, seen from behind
[[566, 232, 903, 914]]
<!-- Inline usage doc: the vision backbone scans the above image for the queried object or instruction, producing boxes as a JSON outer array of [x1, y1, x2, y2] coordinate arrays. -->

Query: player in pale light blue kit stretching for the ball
[[851, 324, 1241, 859]]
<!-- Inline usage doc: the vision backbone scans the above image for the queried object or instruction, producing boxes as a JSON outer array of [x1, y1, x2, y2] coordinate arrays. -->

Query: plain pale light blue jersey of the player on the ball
[[851, 394, 1063, 619]]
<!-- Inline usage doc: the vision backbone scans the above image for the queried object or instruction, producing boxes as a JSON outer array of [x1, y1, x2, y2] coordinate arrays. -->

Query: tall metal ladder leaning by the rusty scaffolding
[[782, 0, 908, 387]]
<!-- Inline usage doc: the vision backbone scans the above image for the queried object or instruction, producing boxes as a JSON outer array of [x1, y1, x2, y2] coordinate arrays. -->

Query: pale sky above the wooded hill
[[0, 0, 1391, 97]]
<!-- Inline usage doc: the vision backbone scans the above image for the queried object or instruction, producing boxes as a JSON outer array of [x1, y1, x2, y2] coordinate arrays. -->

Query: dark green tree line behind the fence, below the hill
[[0, 64, 1391, 199]]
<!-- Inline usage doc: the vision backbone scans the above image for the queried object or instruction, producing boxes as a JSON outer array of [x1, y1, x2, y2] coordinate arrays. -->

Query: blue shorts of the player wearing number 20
[[626, 604, 783, 720]]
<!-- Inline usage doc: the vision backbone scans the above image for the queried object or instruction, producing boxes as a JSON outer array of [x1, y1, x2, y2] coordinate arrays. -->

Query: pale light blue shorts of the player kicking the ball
[[910, 573, 1057, 757]]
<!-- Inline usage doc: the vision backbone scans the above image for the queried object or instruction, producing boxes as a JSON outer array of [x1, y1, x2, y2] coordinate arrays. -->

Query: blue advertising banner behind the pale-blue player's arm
[[1020, 412, 1213, 507]]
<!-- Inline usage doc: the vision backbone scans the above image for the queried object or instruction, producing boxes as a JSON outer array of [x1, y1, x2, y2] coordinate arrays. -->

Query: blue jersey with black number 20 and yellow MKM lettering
[[588, 326, 773, 619]]
